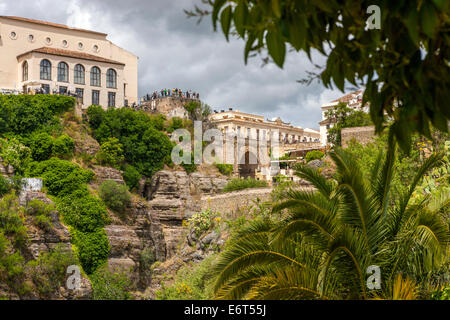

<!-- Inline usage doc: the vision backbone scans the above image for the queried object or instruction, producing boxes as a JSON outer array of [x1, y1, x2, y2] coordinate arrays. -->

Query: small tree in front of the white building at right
[[326, 102, 372, 146]]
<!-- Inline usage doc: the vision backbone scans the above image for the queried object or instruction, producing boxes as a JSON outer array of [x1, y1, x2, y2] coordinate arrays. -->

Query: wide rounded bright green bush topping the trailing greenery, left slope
[[27, 158, 94, 197]]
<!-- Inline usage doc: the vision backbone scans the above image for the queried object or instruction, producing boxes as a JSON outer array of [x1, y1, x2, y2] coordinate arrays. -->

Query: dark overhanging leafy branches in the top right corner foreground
[[186, 0, 450, 150]]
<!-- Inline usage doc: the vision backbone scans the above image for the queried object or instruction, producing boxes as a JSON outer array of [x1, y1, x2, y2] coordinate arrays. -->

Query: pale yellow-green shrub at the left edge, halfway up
[[0, 138, 31, 174]]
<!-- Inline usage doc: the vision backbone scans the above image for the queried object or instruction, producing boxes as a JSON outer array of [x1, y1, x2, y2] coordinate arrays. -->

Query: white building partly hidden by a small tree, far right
[[319, 90, 369, 146]]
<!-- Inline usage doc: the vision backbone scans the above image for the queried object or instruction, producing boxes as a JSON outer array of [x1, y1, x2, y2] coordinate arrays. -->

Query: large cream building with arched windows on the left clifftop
[[0, 16, 138, 108]]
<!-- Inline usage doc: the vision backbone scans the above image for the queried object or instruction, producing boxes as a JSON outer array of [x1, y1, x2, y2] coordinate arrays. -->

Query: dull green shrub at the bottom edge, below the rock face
[[90, 268, 133, 300]]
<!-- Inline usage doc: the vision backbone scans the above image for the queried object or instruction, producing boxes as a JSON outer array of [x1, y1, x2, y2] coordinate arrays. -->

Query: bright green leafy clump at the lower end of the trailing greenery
[[72, 229, 110, 274]]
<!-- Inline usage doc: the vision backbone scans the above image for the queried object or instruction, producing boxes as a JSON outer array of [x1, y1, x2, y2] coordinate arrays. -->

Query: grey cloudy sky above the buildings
[[0, 0, 343, 128]]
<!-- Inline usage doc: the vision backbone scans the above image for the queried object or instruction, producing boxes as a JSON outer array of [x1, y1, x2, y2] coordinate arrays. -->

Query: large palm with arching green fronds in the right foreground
[[215, 135, 450, 299]]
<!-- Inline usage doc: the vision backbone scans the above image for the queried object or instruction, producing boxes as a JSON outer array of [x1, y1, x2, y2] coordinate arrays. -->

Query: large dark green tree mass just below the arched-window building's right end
[[87, 106, 172, 177]]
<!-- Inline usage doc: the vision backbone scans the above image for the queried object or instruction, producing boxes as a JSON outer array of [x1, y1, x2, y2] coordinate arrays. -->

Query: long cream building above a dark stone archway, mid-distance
[[209, 109, 320, 181]]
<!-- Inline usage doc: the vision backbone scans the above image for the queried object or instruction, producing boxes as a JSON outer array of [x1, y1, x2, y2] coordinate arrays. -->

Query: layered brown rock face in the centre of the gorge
[[103, 170, 227, 290]]
